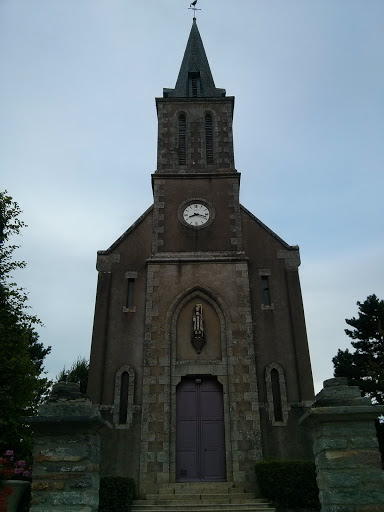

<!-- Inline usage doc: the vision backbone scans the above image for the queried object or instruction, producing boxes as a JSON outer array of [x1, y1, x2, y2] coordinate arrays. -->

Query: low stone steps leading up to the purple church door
[[132, 482, 275, 512]]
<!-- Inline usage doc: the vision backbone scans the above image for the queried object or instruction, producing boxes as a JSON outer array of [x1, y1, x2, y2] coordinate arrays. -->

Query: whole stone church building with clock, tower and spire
[[88, 20, 314, 494]]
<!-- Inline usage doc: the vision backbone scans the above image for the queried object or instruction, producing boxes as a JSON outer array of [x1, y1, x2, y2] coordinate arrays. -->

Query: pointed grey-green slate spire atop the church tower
[[164, 18, 225, 98]]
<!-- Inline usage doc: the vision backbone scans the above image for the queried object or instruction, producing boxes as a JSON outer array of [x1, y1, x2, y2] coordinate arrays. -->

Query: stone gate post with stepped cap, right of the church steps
[[300, 378, 384, 512]]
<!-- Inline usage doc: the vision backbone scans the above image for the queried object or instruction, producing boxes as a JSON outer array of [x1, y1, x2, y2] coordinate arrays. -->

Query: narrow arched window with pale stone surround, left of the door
[[113, 365, 135, 428]]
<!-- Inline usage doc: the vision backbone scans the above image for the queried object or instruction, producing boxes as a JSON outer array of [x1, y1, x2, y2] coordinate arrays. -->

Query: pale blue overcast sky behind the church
[[0, 0, 384, 390]]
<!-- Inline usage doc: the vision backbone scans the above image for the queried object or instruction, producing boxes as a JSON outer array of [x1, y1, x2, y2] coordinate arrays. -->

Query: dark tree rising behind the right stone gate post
[[332, 295, 384, 404]]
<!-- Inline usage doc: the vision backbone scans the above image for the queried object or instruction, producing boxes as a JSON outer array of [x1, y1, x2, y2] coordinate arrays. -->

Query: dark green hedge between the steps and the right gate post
[[255, 460, 320, 510]]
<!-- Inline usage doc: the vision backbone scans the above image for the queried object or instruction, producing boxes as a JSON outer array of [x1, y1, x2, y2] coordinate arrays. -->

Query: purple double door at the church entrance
[[176, 377, 226, 482]]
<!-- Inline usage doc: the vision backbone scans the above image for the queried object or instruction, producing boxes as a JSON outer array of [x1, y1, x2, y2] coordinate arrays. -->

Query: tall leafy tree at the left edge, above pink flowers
[[0, 191, 51, 455]]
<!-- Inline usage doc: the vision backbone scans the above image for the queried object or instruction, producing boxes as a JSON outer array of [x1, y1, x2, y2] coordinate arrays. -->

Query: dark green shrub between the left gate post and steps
[[99, 476, 135, 512]]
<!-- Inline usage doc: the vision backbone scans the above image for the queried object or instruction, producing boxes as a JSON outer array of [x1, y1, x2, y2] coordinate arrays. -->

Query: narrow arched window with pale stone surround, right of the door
[[265, 363, 289, 426]]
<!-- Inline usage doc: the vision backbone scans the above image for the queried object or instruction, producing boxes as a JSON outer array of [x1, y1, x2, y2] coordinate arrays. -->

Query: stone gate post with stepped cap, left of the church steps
[[29, 382, 108, 512]]
